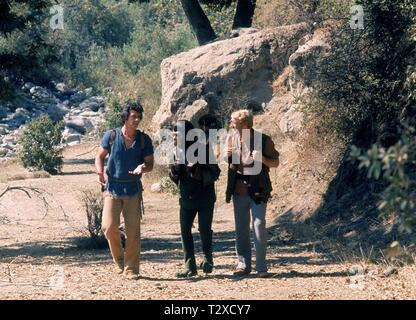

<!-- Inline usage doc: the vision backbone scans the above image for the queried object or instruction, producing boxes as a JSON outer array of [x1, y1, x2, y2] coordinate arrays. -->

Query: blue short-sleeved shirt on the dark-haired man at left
[[101, 128, 153, 196]]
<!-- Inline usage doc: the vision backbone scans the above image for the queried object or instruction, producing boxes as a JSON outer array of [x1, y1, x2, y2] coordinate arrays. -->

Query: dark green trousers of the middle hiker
[[179, 199, 215, 270]]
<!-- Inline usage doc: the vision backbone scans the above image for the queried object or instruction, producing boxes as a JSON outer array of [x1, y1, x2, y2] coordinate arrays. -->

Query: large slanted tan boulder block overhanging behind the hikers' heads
[[153, 24, 308, 128]]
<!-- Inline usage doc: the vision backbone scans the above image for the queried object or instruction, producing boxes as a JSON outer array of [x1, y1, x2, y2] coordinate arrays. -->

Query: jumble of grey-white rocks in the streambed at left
[[0, 82, 105, 160]]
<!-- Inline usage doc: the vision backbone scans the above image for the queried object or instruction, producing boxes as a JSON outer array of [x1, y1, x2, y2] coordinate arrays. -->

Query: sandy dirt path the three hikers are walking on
[[0, 146, 416, 300]]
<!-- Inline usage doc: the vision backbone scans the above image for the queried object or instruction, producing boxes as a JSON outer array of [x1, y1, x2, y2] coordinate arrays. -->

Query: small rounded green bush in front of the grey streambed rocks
[[19, 116, 63, 174]]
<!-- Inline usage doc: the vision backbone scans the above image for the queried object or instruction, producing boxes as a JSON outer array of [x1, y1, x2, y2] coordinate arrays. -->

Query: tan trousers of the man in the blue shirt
[[101, 192, 141, 274]]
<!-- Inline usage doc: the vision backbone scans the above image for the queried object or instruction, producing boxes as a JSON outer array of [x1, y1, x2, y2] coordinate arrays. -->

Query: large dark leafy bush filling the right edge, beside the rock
[[306, 0, 416, 232]]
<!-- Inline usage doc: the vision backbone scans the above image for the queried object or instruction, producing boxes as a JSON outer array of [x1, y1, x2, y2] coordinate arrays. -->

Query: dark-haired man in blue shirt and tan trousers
[[95, 102, 154, 279]]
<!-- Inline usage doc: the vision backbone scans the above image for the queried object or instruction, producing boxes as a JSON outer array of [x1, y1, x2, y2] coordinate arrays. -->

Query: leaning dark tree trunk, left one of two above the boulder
[[181, 0, 217, 45]]
